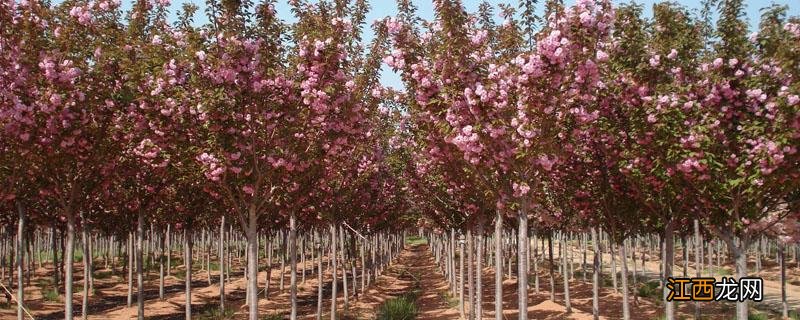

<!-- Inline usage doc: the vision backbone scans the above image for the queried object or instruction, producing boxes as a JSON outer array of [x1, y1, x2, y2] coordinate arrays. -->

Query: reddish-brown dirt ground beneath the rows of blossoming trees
[[0, 244, 800, 320]]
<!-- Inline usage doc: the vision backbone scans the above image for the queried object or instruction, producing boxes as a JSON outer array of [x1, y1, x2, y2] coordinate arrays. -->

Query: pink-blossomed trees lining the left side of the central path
[[0, 0, 406, 319]]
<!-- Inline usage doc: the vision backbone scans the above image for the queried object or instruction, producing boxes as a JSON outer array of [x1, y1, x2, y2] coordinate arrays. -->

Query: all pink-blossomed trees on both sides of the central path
[[0, 0, 800, 319]]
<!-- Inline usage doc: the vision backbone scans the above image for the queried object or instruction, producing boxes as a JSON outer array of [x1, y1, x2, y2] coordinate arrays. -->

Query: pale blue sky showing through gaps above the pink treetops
[[145, 0, 800, 88]]
